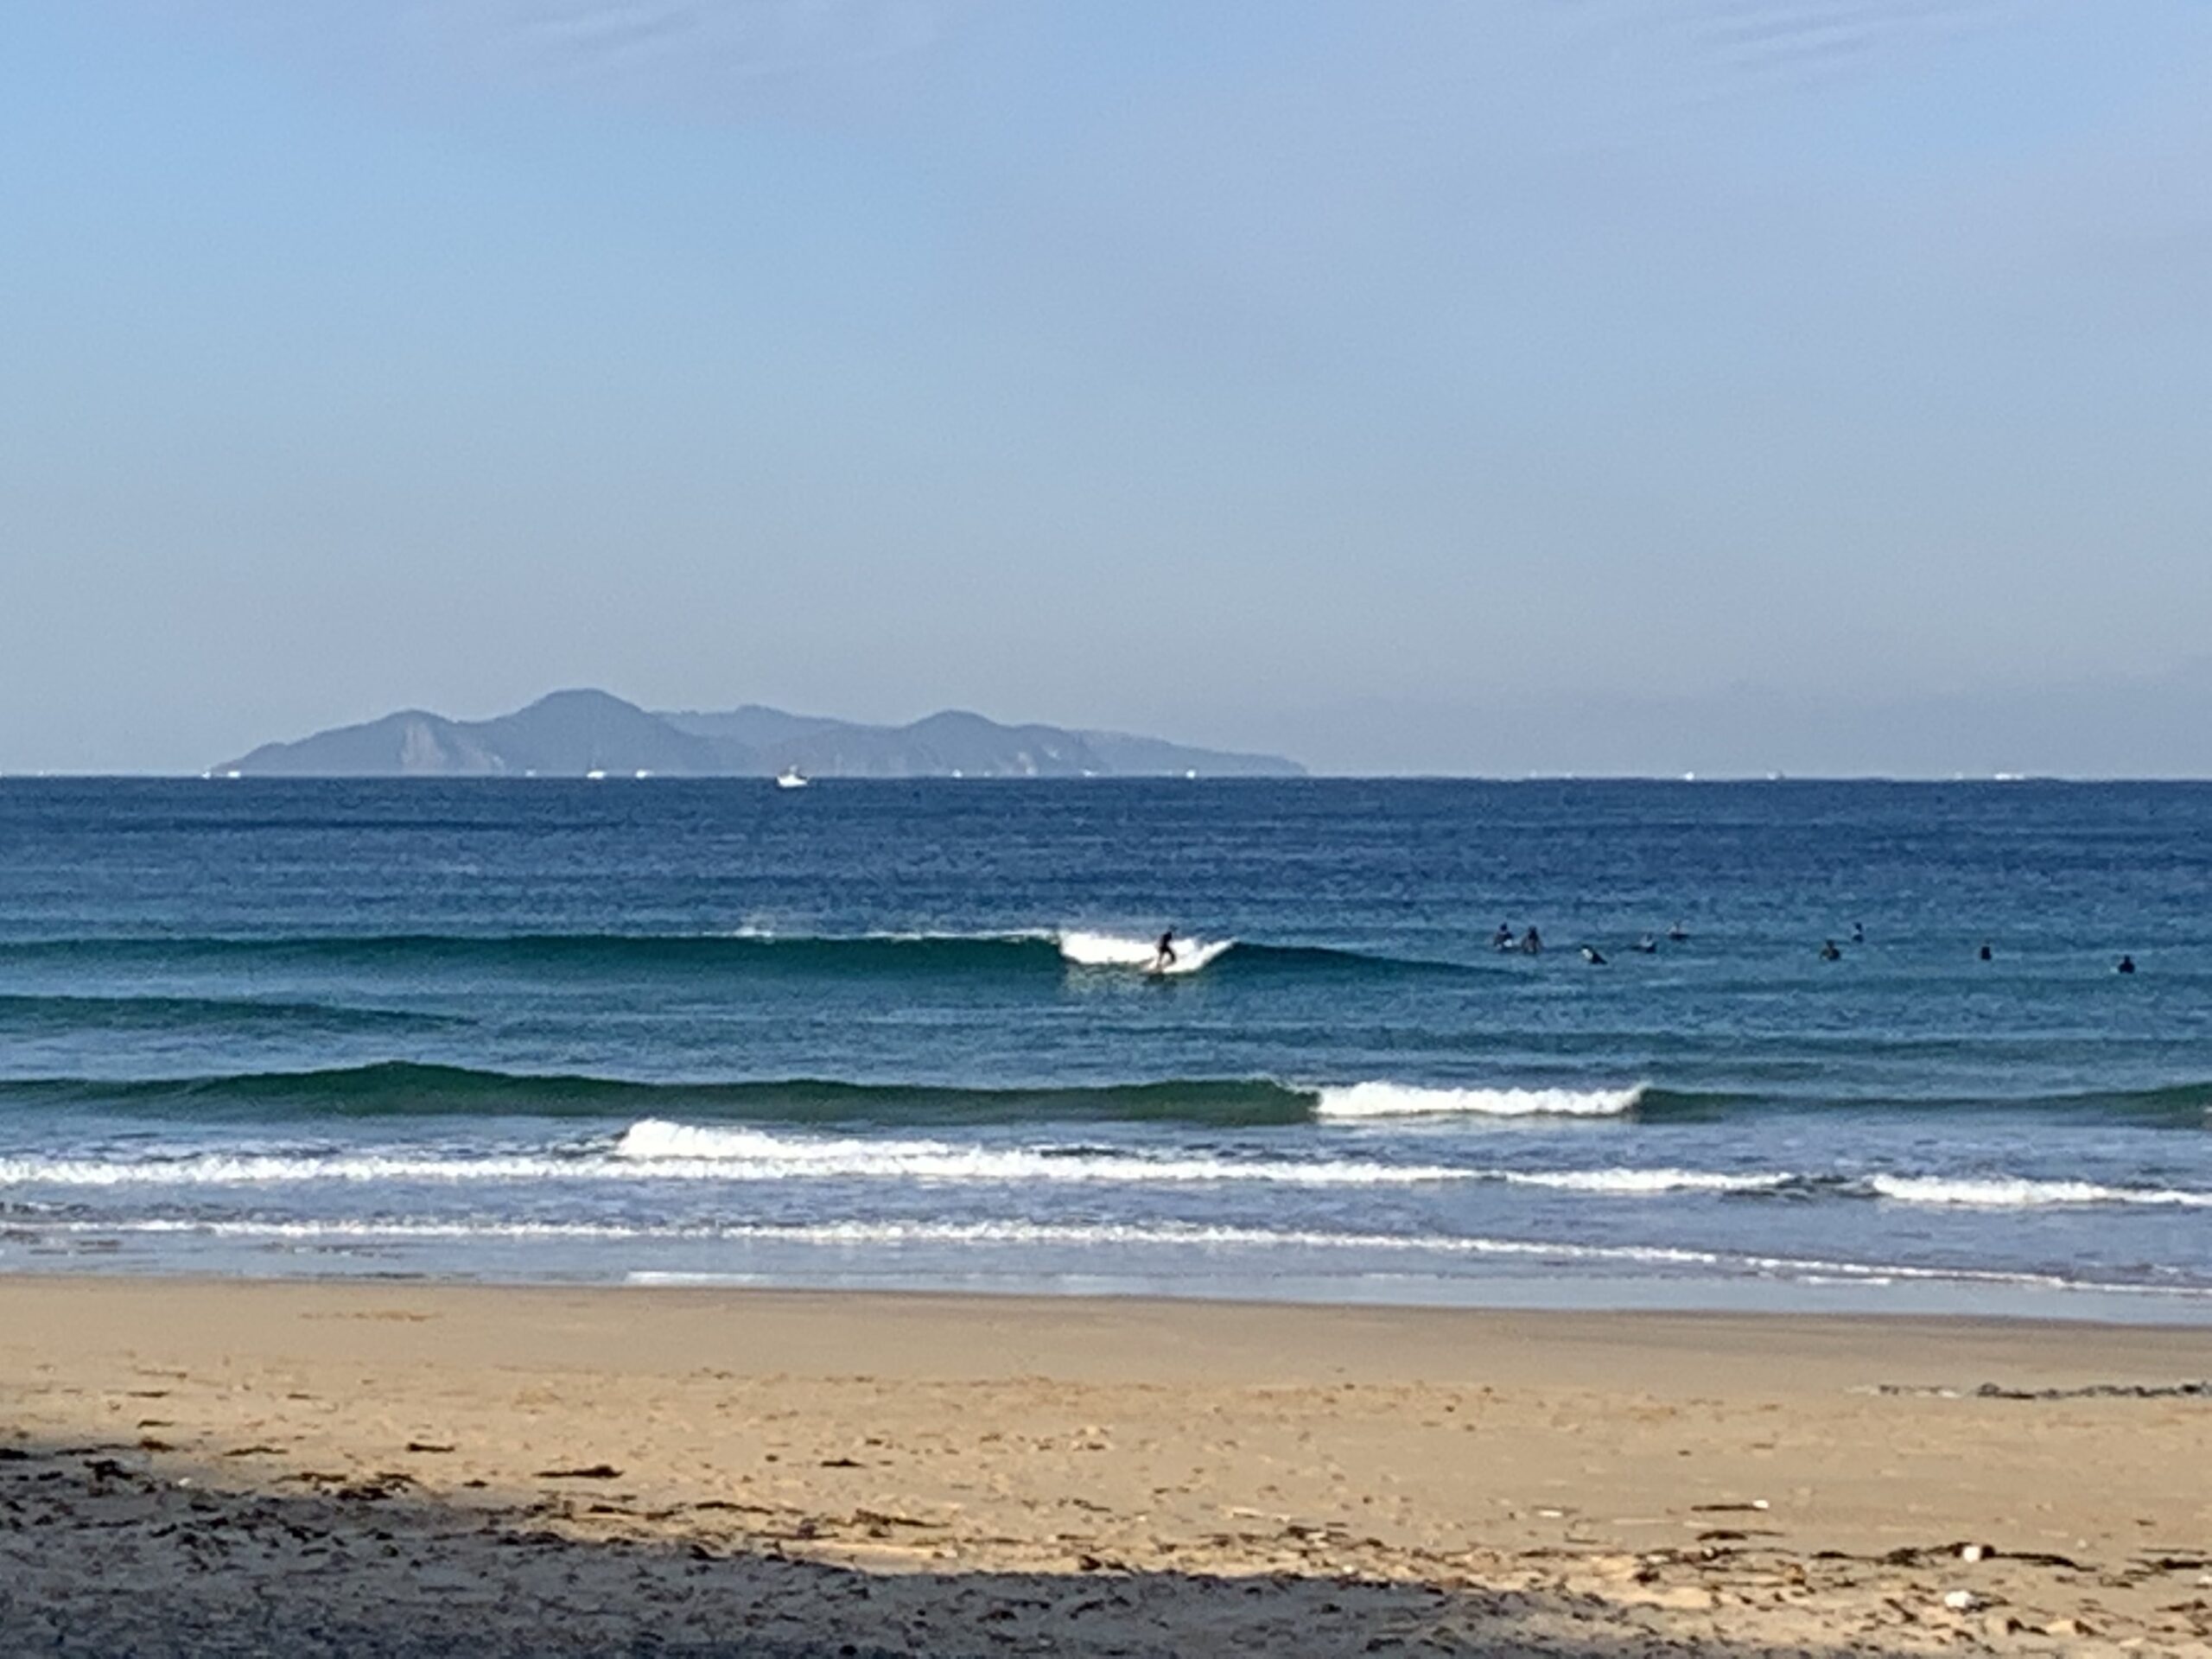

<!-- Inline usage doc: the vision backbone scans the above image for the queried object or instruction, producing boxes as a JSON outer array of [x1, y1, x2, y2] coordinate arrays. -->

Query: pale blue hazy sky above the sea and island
[[0, 0, 2212, 770]]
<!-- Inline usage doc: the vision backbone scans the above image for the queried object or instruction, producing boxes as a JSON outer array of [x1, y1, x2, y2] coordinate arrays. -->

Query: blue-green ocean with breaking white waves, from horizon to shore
[[0, 779, 2212, 1320]]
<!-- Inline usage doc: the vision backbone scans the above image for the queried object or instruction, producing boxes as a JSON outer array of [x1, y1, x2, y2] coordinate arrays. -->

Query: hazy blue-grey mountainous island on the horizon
[[210, 690, 1305, 779]]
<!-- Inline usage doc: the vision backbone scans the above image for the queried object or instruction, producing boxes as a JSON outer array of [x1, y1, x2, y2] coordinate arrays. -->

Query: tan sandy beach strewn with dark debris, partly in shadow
[[0, 1279, 2212, 1659]]
